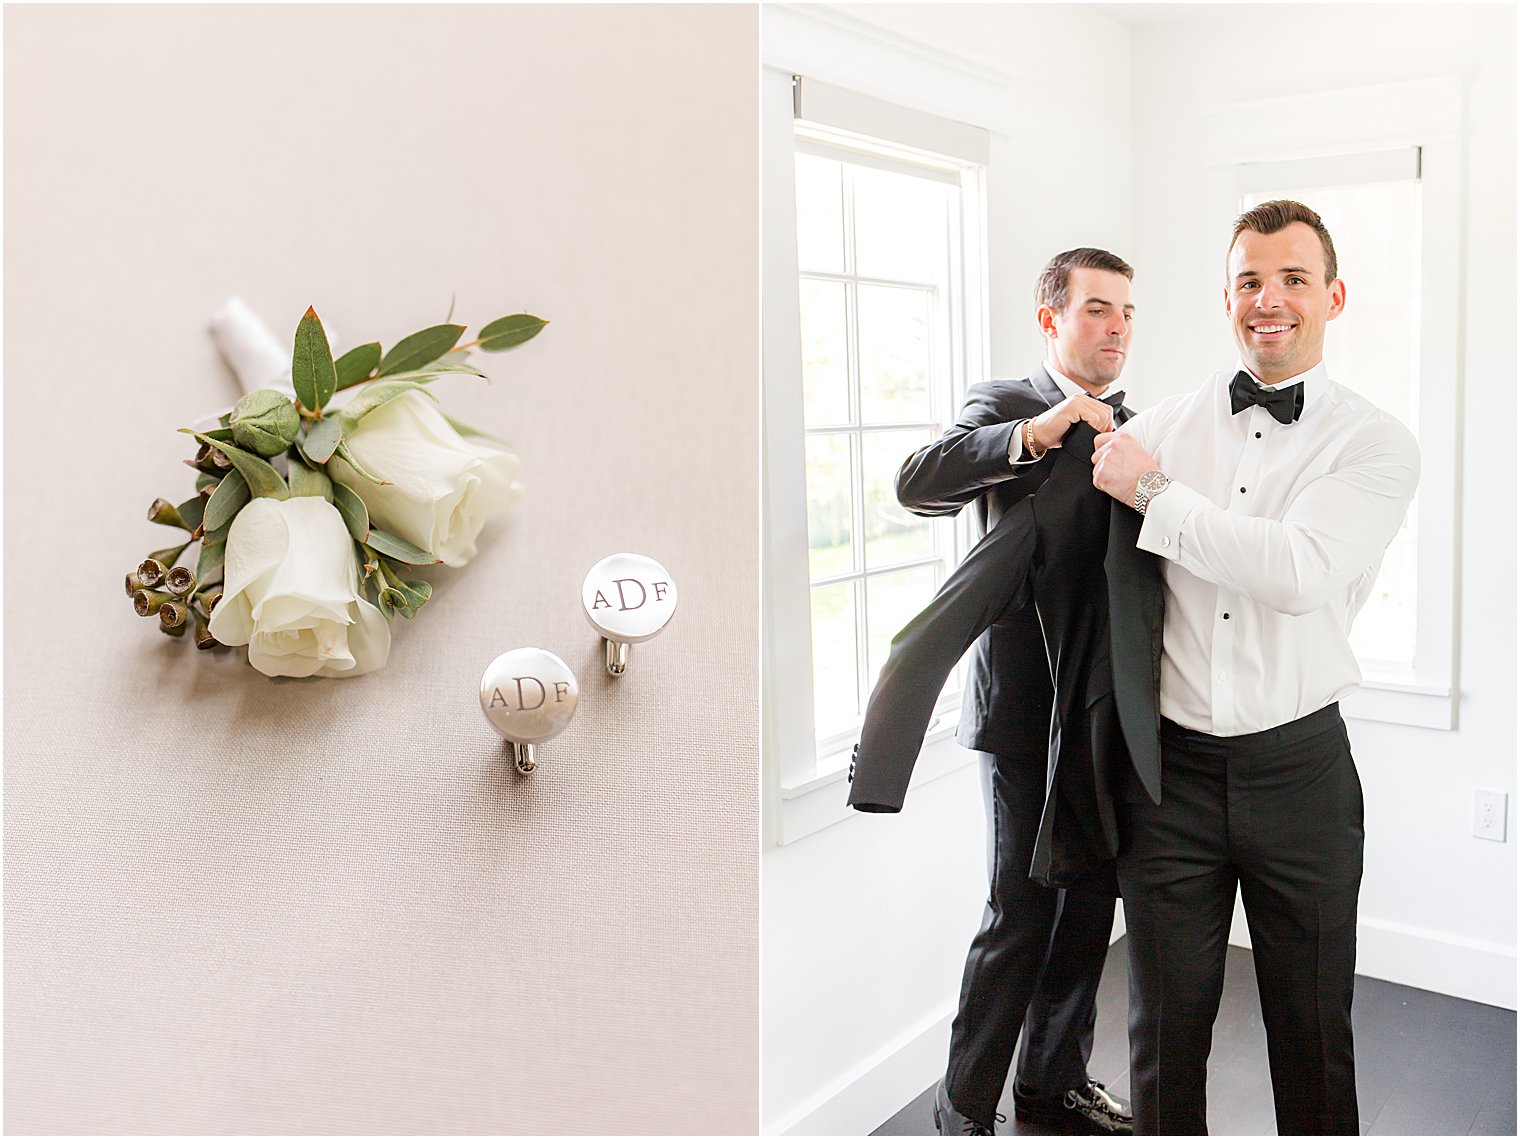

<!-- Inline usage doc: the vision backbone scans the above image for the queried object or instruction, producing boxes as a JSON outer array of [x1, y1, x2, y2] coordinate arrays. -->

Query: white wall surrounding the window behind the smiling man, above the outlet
[[1129, 5, 1515, 1008]]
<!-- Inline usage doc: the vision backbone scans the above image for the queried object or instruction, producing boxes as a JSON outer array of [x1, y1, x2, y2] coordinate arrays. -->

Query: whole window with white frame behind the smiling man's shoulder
[[1202, 79, 1462, 730]]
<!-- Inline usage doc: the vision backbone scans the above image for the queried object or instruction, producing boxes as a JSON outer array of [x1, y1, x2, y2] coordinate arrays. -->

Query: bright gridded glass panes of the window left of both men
[[795, 139, 965, 771]]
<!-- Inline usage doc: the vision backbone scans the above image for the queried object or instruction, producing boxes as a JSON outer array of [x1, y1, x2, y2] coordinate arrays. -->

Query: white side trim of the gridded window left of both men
[[760, 65, 990, 842]]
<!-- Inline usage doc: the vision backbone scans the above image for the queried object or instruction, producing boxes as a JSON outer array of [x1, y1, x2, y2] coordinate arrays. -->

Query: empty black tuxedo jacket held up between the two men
[[850, 423, 1163, 890]]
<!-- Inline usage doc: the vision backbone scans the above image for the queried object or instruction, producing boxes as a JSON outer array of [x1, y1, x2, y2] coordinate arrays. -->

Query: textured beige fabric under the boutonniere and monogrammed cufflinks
[[5, 6, 757, 1133]]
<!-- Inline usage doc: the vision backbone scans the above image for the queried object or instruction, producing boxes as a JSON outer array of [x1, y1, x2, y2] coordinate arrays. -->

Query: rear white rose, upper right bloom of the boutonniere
[[327, 391, 523, 566]]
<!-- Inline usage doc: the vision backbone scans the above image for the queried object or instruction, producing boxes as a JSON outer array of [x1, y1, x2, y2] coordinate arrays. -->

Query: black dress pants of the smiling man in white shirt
[[1119, 704, 1362, 1134]]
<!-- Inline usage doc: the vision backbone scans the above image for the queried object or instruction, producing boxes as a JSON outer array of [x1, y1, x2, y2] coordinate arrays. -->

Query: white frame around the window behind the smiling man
[[1204, 79, 1464, 730]]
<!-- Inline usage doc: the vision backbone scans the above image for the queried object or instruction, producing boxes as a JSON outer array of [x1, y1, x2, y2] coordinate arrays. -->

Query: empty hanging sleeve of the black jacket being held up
[[850, 499, 1035, 812]]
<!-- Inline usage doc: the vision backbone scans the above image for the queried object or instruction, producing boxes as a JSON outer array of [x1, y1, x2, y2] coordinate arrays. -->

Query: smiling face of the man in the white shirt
[[1225, 222, 1345, 383]]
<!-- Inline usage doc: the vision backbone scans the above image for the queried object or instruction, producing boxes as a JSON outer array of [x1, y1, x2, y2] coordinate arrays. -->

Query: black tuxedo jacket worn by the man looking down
[[897, 366, 1066, 762]]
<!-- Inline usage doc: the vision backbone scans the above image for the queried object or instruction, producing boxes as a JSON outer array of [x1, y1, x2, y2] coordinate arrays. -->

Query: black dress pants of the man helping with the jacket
[[945, 751, 1114, 1121]]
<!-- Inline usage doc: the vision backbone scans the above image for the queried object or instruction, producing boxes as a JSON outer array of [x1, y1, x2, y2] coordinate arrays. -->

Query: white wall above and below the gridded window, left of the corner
[[762, 5, 1132, 1134]]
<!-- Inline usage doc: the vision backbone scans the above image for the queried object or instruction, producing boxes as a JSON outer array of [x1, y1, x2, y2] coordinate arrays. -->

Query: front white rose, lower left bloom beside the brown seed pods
[[211, 496, 391, 677]]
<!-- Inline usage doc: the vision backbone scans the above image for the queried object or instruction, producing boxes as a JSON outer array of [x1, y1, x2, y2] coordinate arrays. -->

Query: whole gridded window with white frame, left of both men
[[762, 70, 988, 802]]
